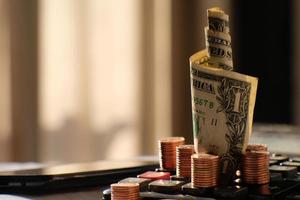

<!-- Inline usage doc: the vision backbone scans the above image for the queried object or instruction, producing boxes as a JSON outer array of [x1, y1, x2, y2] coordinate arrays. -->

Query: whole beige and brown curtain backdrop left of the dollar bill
[[0, 0, 230, 162]]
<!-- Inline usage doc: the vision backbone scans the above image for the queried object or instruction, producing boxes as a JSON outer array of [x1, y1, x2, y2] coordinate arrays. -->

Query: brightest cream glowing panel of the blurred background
[[39, 0, 141, 161]]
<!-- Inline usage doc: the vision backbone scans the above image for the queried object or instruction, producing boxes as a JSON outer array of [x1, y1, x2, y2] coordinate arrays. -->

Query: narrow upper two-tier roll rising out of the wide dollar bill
[[204, 7, 233, 70]]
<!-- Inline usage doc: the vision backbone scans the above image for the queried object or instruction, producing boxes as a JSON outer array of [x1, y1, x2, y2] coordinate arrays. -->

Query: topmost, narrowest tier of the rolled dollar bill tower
[[207, 7, 229, 33]]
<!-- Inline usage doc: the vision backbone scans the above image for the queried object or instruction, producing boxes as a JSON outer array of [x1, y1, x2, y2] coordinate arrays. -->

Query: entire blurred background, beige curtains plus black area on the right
[[0, 0, 300, 162]]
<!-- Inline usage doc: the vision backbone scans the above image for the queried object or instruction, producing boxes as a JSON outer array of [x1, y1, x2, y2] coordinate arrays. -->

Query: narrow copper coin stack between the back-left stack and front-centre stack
[[176, 145, 195, 178]]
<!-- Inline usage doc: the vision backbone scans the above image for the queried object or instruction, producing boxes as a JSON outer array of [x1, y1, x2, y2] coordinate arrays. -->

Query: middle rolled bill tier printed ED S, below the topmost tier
[[204, 27, 233, 70]]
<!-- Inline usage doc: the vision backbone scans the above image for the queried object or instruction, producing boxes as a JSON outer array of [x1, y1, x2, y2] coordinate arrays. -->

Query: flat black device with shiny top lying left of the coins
[[0, 161, 158, 193]]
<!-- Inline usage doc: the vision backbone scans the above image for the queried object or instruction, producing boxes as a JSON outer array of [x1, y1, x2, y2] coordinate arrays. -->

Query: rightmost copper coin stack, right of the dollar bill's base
[[242, 144, 270, 184]]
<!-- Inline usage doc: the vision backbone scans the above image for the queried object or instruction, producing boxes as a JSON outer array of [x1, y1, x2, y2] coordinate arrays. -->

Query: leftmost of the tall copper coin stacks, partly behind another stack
[[158, 137, 185, 171]]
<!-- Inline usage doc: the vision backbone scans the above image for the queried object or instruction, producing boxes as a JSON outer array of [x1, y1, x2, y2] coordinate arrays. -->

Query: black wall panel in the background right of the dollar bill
[[231, 0, 292, 123]]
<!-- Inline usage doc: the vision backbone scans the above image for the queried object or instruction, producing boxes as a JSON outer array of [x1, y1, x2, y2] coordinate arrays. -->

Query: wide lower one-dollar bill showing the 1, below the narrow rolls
[[190, 50, 258, 183]]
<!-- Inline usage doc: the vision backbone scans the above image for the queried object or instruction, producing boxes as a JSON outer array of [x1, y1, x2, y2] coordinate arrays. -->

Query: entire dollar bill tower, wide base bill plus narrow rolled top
[[190, 8, 258, 185]]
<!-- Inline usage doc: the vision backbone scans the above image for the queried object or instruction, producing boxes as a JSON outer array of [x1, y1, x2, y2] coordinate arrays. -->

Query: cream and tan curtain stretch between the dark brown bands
[[39, 0, 175, 161]]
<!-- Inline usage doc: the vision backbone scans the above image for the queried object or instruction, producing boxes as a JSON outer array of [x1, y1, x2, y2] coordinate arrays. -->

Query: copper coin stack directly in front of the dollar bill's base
[[191, 153, 219, 188]]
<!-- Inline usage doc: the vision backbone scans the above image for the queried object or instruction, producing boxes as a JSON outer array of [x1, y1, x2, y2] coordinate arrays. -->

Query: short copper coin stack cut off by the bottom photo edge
[[110, 183, 140, 200]]
